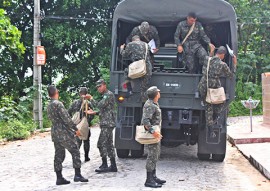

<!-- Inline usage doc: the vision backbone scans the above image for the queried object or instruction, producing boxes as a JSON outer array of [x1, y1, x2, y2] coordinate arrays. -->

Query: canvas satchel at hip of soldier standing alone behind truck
[[135, 125, 160, 144]]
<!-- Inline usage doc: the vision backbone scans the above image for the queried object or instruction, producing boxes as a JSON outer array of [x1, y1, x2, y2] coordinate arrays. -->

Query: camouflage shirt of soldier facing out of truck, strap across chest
[[174, 20, 210, 46]]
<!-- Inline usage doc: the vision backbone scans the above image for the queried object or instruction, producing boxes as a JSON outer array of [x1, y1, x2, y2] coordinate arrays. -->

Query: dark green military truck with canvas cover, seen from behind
[[110, 0, 237, 162]]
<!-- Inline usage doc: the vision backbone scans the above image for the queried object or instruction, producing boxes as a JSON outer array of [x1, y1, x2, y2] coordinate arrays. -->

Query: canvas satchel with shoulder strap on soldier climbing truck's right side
[[205, 57, 226, 104]]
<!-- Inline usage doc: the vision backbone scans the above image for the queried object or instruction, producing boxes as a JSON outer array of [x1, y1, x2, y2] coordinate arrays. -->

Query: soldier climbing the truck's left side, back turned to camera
[[120, 35, 152, 101]]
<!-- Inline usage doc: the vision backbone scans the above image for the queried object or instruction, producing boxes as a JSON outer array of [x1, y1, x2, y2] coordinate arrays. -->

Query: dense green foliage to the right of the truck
[[229, 0, 270, 116]]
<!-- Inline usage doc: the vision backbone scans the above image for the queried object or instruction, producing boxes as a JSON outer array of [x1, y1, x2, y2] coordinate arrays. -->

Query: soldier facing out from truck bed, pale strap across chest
[[174, 12, 215, 73]]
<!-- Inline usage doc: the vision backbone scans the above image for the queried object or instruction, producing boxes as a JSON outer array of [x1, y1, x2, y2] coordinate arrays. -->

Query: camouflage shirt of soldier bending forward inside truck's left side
[[126, 25, 160, 49]]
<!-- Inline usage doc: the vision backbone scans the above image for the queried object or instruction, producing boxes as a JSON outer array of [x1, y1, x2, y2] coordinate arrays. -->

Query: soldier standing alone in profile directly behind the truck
[[141, 86, 166, 188]]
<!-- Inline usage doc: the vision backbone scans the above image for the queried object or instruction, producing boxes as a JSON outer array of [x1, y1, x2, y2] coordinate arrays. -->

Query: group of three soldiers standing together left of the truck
[[47, 79, 118, 185]]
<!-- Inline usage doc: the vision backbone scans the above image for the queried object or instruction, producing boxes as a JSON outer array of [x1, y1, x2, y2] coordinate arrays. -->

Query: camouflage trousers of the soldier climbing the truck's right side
[[205, 103, 224, 127]]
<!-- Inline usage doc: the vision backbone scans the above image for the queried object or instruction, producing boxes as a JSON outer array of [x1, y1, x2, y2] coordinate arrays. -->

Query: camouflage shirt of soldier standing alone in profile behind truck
[[141, 99, 161, 127]]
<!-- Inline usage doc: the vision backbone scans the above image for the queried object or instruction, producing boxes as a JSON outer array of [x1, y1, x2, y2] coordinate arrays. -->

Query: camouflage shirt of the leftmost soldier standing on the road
[[47, 99, 78, 142]]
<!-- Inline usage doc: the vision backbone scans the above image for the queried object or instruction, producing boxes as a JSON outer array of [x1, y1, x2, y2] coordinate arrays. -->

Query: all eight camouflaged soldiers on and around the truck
[[48, 13, 237, 188]]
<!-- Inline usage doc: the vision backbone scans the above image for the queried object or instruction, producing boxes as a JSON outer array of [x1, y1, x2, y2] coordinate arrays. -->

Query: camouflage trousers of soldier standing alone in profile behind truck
[[146, 142, 160, 172]]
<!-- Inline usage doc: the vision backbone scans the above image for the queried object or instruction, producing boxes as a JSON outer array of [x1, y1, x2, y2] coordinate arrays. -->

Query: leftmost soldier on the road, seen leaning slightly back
[[47, 85, 88, 185]]
